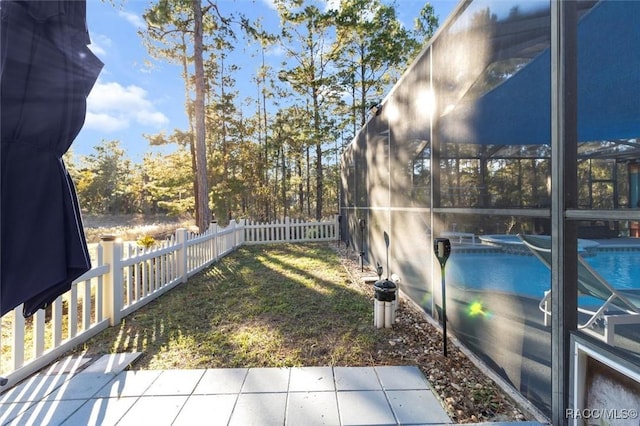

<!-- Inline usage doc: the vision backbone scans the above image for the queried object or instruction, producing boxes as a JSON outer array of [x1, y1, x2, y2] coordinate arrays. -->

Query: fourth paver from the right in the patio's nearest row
[[229, 393, 287, 426]]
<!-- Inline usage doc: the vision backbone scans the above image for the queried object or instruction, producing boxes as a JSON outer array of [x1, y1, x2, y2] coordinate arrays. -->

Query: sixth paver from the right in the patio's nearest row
[[118, 395, 188, 426]]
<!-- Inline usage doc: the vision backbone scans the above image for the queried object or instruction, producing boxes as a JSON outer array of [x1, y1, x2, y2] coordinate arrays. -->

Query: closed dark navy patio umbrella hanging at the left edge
[[0, 0, 103, 316]]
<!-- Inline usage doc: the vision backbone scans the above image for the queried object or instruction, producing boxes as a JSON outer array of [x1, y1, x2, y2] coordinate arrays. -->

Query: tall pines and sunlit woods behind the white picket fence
[[67, 0, 438, 229]]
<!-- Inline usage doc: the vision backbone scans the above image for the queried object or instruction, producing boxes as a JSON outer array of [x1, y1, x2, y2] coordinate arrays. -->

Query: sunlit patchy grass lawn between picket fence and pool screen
[[74, 243, 388, 369]]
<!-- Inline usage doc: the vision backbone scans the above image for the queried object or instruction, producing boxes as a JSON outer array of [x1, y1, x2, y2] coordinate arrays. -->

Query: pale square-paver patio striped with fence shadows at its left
[[0, 354, 452, 426]]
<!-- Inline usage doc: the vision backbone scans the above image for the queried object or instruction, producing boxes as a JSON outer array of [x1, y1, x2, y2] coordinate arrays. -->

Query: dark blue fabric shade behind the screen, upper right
[[439, 1, 640, 145]]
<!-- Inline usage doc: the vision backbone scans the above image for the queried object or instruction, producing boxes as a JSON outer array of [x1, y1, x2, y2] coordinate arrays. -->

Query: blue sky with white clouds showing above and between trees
[[71, 0, 457, 162]]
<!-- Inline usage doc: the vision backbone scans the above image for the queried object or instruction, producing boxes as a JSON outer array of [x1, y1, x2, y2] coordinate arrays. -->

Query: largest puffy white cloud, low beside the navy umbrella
[[85, 80, 169, 133]]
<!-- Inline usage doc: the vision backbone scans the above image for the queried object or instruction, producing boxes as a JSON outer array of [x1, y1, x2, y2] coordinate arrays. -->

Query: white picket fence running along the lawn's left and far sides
[[0, 217, 338, 393]]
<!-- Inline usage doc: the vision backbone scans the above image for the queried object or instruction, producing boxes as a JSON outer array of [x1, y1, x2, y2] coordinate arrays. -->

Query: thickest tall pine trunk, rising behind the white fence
[[191, 0, 211, 232]]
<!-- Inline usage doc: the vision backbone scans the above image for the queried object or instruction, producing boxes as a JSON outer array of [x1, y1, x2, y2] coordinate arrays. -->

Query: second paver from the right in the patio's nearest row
[[337, 391, 397, 426]]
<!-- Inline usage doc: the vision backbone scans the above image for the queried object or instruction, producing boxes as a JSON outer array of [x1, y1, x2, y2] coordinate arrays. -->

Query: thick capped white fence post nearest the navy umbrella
[[100, 235, 122, 327]]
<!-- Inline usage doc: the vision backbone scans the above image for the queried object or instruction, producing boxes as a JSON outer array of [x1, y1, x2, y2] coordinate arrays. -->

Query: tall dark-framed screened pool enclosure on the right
[[341, 0, 640, 424]]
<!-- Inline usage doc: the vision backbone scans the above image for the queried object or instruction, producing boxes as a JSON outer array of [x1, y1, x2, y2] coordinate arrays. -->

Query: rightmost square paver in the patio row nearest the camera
[[387, 390, 452, 424]]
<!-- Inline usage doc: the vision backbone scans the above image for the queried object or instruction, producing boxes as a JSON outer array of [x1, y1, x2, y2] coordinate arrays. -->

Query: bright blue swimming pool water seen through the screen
[[446, 251, 640, 298]]
